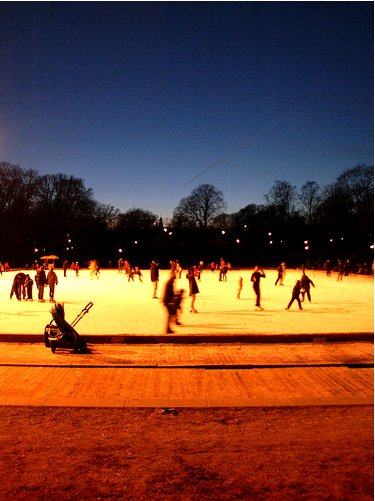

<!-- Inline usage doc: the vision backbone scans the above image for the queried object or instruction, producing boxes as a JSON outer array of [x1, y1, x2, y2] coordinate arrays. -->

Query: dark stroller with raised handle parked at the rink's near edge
[[44, 302, 94, 353]]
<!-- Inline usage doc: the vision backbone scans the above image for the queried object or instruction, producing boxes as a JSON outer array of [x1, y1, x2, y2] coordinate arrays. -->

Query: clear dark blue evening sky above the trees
[[0, 2, 374, 217]]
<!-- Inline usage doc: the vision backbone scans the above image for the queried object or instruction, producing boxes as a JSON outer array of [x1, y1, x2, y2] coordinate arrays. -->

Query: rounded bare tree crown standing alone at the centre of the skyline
[[173, 184, 226, 229]]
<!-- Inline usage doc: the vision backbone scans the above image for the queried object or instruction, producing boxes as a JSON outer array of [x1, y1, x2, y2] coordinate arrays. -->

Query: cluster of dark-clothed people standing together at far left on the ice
[[10, 265, 58, 303]]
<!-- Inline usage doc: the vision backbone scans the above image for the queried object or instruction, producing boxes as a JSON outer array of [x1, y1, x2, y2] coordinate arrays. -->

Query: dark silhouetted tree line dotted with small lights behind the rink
[[0, 162, 374, 266]]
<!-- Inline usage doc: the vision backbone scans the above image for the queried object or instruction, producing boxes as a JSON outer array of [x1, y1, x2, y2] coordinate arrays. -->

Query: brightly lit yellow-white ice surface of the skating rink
[[0, 266, 374, 342]]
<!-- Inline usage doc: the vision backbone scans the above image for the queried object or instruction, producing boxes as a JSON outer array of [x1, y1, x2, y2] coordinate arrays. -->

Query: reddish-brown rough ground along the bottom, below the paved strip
[[0, 406, 374, 501]]
